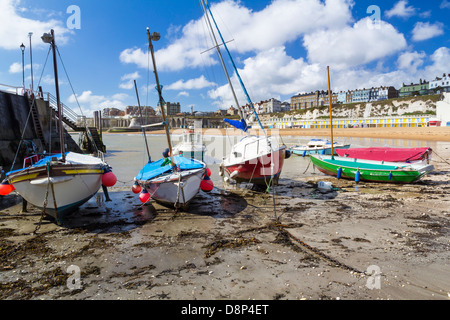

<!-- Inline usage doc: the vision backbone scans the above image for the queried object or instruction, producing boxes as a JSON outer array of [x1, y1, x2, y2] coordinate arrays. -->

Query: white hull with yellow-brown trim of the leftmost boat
[[8, 164, 104, 220]]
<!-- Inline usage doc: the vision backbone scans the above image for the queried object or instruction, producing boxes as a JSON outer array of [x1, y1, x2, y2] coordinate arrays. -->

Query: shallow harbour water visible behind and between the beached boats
[[96, 134, 450, 186]]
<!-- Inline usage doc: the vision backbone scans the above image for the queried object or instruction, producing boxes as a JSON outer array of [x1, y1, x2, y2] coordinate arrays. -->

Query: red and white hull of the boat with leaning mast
[[222, 146, 286, 185]]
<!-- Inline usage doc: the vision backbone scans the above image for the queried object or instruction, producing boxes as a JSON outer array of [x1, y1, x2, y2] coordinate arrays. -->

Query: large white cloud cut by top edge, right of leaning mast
[[202, 0, 352, 53]]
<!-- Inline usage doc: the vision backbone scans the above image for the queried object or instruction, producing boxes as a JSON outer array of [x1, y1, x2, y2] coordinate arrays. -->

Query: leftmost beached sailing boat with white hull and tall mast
[[1, 30, 117, 223]]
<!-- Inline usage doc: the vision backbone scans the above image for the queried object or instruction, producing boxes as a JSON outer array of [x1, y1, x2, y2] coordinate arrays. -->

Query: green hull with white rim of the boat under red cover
[[310, 155, 434, 183]]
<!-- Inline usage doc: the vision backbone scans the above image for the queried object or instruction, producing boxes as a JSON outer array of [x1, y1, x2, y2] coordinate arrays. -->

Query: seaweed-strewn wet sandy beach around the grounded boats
[[0, 128, 450, 302]]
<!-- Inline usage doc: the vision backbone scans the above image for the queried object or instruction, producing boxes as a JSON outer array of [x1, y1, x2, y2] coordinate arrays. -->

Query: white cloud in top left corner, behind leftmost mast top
[[0, 0, 70, 50]]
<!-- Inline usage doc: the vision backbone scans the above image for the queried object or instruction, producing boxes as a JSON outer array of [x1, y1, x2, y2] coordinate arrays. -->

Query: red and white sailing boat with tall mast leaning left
[[200, 0, 287, 186]]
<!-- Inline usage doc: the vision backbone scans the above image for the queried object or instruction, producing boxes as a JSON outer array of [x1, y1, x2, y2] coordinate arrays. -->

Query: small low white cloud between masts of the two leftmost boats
[[68, 90, 128, 116]]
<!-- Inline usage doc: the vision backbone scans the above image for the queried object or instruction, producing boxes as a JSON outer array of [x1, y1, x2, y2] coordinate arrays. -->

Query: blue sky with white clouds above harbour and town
[[0, 0, 450, 117]]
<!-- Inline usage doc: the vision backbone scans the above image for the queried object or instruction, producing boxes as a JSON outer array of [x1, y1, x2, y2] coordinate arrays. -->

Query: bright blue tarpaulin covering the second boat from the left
[[136, 156, 203, 180]]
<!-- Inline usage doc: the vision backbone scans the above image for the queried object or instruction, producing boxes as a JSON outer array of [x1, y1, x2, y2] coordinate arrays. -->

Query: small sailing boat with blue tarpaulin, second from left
[[133, 28, 208, 209]]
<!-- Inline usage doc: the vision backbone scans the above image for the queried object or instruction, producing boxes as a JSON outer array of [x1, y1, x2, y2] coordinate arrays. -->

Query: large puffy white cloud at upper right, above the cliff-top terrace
[[304, 18, 406, 69]]
